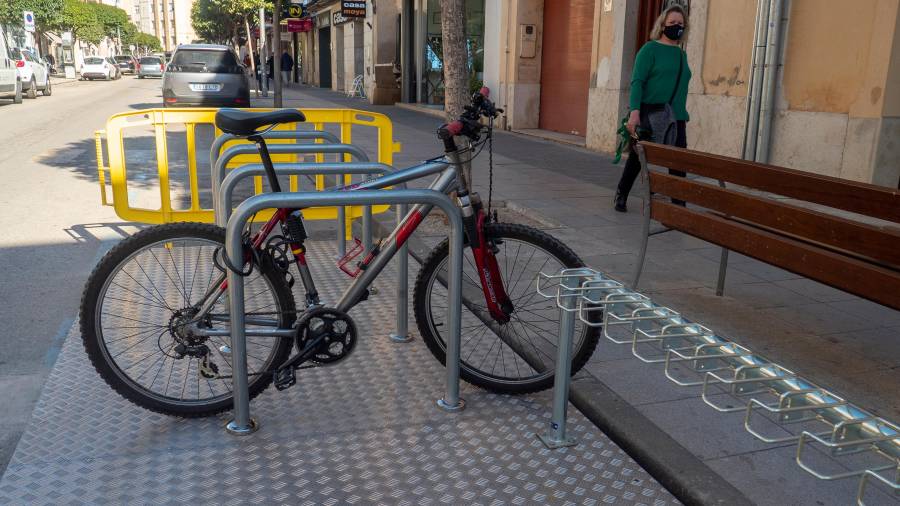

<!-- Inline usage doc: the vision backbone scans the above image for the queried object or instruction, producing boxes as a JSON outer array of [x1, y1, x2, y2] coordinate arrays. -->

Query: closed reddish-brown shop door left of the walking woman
[[539, 0, 594, 137]]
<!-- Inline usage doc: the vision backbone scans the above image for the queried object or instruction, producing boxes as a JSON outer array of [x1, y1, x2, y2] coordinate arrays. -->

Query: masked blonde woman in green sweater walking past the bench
[[615, 5, 691, 213]]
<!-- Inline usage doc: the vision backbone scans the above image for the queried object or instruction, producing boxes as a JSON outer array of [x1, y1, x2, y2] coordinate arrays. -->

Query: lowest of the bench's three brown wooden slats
[[650, 199, 900, 310]]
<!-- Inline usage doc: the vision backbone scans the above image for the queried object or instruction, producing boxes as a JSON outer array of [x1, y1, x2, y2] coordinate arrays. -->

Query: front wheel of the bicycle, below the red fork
[[413, 223, 598, 394]]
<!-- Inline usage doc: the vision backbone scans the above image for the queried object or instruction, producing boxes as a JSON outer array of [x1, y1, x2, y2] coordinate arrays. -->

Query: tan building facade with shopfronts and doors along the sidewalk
[[303, 0, 900, 188]]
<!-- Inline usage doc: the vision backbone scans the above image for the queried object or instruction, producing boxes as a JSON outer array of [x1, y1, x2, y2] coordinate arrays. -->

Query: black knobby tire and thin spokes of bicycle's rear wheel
[[80, 222, 296, 418]]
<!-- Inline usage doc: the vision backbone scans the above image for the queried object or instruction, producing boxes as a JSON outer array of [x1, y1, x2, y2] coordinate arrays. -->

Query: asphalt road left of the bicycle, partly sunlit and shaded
[[0, 76, 165, 474]]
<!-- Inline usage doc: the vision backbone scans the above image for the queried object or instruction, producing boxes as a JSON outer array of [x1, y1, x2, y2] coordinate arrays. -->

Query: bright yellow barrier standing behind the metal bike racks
[[95, 108, 400, 224]]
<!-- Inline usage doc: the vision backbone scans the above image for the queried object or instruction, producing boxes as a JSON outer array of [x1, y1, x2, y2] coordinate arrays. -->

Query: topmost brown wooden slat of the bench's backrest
[[641, 142, 900, 223]]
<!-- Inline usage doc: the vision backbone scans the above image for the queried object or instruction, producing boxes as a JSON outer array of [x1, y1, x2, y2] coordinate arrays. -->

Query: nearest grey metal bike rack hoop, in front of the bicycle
[[225, 189, 465, 435]]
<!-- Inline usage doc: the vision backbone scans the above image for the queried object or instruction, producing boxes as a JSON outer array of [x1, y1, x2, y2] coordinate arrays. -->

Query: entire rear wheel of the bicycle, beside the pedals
[[80, 223, 296, 417]]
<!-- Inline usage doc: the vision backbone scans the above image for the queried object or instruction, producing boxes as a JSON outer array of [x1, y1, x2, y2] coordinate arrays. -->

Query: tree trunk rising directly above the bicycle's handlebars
[[441, 0, 469, 120]]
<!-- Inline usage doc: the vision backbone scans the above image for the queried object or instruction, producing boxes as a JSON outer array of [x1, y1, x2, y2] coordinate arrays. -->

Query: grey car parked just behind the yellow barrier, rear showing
[[162, 44, 250, 107]]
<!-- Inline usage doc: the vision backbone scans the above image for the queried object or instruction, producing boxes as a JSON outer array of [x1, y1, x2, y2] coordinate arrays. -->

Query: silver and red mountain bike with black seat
[[80, 88, 599, 417]]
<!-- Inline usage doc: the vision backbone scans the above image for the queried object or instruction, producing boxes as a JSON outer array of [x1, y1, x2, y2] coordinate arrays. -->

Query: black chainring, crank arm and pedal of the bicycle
[[274, 307, 358, 390]]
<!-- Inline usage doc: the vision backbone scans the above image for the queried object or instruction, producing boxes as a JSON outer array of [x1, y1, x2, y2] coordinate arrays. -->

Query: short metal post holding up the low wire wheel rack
[[538, 274, 581, 450]]
